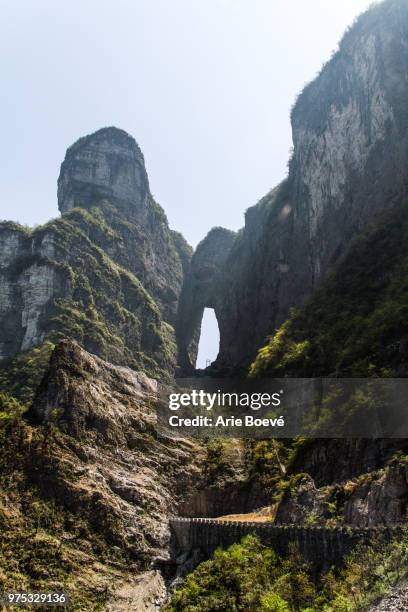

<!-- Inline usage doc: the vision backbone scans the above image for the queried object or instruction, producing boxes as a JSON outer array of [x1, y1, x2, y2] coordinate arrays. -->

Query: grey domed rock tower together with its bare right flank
[[58, 128, 191, 325]]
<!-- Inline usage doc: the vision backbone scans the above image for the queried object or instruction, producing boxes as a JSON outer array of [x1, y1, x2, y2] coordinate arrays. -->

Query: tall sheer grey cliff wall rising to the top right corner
[[207, 0, 408, 367]]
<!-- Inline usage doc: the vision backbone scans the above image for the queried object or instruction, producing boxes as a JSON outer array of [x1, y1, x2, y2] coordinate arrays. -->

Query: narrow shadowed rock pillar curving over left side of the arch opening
[[176, 227, 235, 374]]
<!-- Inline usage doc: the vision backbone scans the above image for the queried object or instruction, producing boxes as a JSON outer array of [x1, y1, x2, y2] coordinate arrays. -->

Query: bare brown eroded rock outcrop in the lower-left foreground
[[25, 341, 205, 560]]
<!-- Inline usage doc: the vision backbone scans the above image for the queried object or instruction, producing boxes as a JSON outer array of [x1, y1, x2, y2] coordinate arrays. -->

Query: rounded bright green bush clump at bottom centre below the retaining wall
[[165, 536, 317, 612]]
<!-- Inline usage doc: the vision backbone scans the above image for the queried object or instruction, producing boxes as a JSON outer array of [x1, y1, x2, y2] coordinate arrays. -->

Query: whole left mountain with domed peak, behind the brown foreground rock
[[0, 128, 190, 376]]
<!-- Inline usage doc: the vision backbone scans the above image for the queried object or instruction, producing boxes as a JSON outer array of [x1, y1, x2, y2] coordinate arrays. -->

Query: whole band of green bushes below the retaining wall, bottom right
[[165, 533, 408, 612]]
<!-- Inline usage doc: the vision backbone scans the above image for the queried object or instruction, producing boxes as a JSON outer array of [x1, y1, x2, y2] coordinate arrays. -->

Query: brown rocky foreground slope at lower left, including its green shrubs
[[0, 341, 205, 610]]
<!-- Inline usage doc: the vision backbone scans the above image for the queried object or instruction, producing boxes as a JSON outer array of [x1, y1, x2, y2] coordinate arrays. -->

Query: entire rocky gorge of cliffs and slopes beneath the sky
[[0, 0, 408, 612]]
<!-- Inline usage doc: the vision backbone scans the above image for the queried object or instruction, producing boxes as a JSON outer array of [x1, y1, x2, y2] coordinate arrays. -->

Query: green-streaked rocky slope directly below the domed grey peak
[[0, 209, 176, 382]]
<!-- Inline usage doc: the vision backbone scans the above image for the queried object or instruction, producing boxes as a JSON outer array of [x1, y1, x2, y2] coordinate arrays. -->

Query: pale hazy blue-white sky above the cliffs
[[0, 0, 369, 363]]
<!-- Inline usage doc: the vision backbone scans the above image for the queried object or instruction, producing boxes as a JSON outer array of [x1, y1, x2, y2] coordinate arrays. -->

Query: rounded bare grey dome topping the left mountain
[[58, 127, 150, 216]]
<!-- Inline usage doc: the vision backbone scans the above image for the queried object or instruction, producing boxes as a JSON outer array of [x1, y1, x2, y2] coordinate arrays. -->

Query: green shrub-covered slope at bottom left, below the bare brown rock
[[0, 418, 127, 611]]
